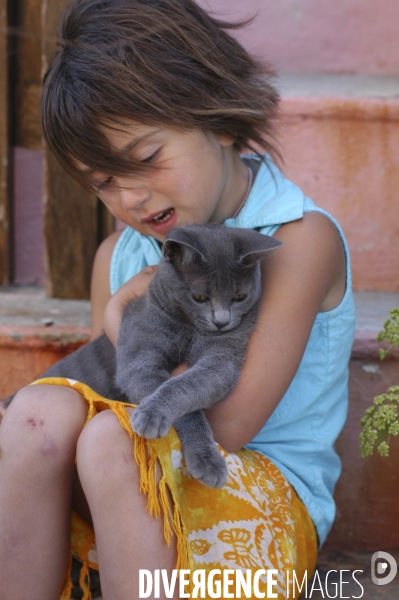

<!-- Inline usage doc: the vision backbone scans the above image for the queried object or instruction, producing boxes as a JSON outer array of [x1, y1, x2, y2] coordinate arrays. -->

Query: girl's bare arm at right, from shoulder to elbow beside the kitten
[[206, 212, 346, 452]]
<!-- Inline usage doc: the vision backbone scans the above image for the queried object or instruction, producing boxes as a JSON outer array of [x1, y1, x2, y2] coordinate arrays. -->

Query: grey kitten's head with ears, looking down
[[159, 224, 281, 333]]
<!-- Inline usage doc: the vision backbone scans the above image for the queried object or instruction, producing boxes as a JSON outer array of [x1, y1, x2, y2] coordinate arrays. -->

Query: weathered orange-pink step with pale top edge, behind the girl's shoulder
[[278, 74, 399, 291]]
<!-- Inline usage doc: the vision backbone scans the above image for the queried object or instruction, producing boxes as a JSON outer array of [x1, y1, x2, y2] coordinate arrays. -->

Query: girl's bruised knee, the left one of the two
[[0, 385, 87, 455]]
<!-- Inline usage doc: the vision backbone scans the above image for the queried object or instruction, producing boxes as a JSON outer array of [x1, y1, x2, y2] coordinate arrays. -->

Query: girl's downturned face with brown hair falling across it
[[78, 122, 248, 241]]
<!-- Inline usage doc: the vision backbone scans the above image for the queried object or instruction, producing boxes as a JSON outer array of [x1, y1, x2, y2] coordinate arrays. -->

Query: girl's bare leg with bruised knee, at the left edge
[[0, 385, 87, 600]]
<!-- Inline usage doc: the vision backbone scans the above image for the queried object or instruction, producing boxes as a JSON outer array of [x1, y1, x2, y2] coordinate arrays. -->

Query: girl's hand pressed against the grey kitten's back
[[103, 265, 157, 346]]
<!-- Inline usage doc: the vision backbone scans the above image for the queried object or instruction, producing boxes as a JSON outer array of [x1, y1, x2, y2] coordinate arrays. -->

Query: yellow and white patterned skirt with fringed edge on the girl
[[33, 378, 317, 600]]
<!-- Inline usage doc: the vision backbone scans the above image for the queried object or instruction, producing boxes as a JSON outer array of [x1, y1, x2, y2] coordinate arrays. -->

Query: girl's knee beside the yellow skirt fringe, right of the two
[[76, 410, 138, 483]]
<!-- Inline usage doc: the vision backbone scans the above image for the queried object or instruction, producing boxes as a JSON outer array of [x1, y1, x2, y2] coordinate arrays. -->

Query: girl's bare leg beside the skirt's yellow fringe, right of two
[[77, 410, 179, 600]]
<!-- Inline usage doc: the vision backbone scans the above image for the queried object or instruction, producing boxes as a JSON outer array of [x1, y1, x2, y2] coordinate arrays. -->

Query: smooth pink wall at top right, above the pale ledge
[[197, 0, 399, 74]]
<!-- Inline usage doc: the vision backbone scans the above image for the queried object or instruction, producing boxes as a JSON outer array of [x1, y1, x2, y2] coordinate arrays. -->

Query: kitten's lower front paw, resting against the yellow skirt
[[185, 446, 228, 488]]
